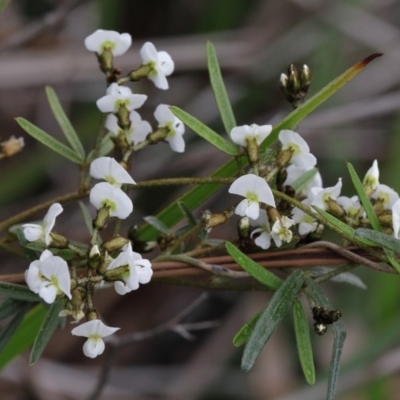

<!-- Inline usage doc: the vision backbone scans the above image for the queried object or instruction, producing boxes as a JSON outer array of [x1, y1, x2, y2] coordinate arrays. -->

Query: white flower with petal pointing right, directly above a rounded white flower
[[90, 157, 135, 187]]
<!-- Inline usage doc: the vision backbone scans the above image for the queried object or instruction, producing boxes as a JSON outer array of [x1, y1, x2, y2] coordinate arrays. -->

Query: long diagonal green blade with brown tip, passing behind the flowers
[[140, 54, 379, 240]]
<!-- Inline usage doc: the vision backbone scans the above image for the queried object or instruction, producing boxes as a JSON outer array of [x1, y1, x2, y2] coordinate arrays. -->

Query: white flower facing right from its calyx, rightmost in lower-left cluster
[[107, 243, 153, 295]]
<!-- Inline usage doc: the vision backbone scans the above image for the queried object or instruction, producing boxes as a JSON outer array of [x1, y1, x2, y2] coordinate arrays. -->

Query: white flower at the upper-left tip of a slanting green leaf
[[154, 104, 185, 153]]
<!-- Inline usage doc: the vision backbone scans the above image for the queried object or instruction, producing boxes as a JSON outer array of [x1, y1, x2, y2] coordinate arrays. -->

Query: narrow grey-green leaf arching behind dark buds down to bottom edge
[[307, 278, 346, 400]]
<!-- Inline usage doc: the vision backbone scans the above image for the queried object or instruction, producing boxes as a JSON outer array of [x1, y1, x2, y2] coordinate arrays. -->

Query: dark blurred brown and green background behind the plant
[[0, 0, 400, 400]]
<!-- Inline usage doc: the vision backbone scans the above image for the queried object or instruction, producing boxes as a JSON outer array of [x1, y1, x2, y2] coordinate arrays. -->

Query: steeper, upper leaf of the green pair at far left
[[46, 86, 85, 160]]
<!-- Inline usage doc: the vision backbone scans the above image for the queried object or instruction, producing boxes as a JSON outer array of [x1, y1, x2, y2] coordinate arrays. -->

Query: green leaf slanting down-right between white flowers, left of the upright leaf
[[170, 106, 238, 156]]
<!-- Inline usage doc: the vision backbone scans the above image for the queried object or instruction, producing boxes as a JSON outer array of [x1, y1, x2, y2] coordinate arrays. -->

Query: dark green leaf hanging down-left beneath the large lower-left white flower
[[29, 300, 65, 365]]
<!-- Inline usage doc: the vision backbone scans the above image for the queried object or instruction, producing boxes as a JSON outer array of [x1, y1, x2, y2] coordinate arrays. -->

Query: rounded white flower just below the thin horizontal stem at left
[[89, 182, 133, 219]]
